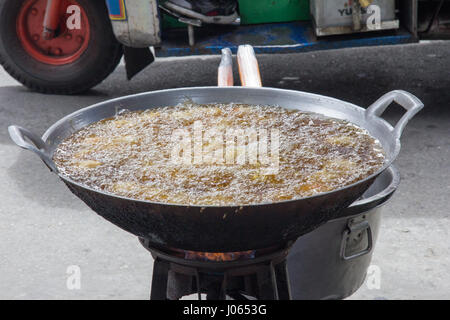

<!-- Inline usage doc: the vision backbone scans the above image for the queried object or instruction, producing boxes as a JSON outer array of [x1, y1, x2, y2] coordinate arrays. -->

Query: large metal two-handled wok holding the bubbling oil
[[9, 87, 423, 252]]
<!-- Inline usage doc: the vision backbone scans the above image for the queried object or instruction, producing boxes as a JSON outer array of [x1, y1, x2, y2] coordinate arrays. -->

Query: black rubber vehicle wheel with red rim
[[0, 0, 122, 94]]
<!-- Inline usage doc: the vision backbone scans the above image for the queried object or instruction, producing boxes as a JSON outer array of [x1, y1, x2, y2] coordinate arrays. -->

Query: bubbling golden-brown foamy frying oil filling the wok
[[54, 103, 385, 205]]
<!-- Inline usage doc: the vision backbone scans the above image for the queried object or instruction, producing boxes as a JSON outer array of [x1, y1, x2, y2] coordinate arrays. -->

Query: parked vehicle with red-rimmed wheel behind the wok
[[0, 0, 450, 94]]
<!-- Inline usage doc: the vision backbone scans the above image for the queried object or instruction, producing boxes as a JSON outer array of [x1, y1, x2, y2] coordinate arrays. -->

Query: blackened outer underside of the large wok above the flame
[[62, 179, 374, 252]]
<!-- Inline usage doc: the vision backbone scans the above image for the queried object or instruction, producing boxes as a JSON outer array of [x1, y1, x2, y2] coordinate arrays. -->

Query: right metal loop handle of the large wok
[[366, 90, 423, 139]]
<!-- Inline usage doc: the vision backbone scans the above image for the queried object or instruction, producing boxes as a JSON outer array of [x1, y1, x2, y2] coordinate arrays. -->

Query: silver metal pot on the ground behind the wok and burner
[[288, 166, 400, 300]]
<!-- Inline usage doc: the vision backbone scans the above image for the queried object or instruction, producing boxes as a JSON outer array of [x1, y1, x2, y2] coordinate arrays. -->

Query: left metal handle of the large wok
[[8, 126, 58, 173]]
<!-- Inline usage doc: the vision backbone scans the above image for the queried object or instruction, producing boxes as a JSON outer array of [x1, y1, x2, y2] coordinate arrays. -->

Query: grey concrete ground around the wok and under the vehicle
[[0, 42, 450, 299]]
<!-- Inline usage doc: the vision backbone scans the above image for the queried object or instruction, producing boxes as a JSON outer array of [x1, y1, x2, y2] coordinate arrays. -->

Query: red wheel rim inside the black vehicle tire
[[17, 0, 90, 65]]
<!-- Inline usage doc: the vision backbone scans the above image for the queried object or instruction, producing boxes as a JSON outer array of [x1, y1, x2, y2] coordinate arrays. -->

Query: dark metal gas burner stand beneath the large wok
[[139, 238, 291, 300]]
